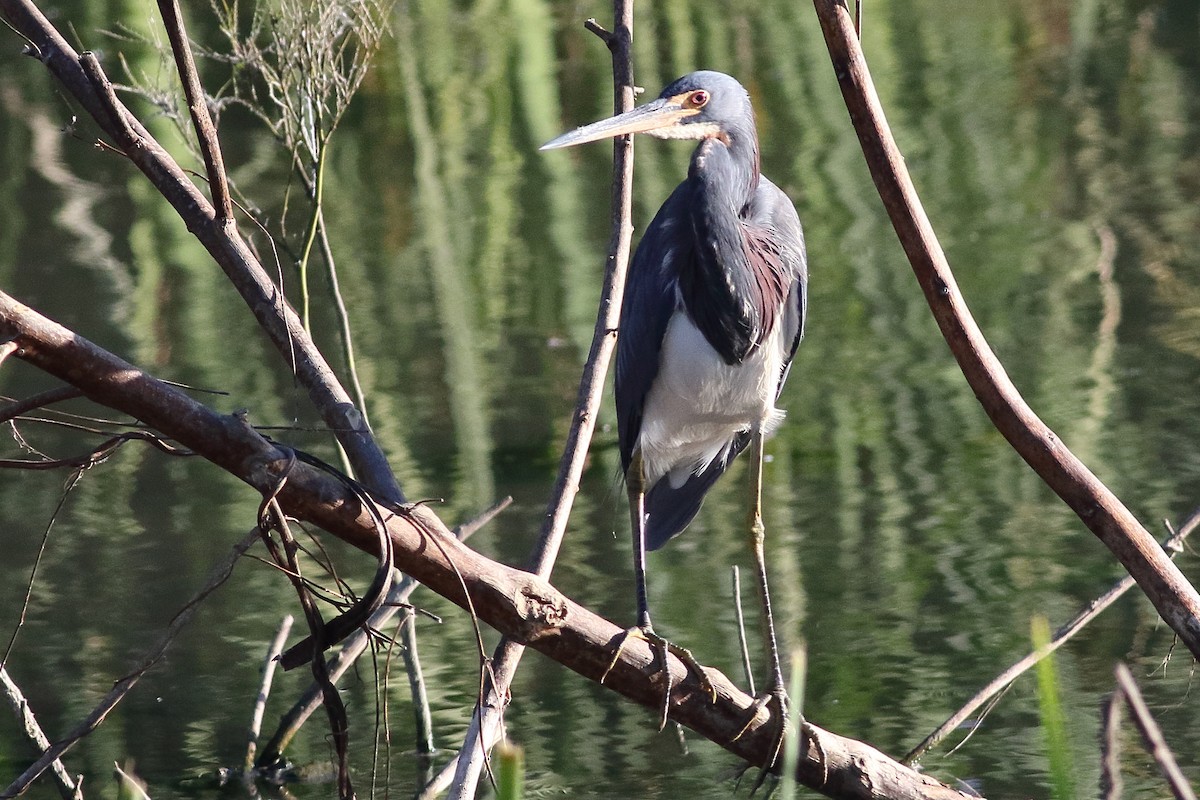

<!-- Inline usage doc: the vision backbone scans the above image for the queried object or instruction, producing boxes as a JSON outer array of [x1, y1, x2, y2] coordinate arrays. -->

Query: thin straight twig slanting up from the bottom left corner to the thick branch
[[0, 529, 258, 799]]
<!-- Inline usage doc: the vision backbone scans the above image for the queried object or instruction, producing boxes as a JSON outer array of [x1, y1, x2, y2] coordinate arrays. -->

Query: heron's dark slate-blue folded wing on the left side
[[616, 185, 692, 473]]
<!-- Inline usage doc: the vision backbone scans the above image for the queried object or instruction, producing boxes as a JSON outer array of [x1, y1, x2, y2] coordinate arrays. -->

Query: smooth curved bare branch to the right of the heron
[[814, 0, 1200, 658]]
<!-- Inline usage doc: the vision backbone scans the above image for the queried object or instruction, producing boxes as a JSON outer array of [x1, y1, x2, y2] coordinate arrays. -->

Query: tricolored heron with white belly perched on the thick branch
[[541, 72, 808, 746]]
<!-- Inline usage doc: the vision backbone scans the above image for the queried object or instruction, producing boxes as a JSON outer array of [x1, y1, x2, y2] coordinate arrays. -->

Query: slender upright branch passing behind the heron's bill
[[450, 0, 634, 800]]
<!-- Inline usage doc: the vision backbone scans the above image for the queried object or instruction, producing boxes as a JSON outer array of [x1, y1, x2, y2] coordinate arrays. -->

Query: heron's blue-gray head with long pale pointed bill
[[541, 70, 754, 150]]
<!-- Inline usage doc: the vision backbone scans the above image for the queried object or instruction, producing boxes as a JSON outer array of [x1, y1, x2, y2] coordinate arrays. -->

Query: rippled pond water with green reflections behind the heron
[[0, 0, 1200, 798]]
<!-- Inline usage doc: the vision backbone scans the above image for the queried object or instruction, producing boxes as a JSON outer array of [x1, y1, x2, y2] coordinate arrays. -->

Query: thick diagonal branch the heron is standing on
[[0, 291, 965, 800]]
